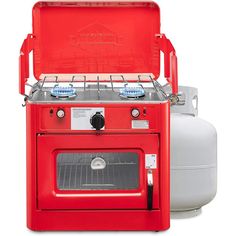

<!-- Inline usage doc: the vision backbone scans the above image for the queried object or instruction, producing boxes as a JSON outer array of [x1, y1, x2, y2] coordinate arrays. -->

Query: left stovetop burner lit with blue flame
[[51, 84, 77, 98]]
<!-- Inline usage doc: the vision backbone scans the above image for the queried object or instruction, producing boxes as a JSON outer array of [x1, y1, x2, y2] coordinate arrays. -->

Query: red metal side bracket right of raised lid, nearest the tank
[[158, 34, 178, 95]]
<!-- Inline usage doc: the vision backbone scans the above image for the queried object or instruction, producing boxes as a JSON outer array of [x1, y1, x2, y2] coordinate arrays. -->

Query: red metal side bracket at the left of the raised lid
[[19, 34, 33, 95]]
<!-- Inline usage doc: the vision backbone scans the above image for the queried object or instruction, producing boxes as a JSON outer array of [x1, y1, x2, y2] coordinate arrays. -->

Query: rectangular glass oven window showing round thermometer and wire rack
[[57, 152, 139, 190]]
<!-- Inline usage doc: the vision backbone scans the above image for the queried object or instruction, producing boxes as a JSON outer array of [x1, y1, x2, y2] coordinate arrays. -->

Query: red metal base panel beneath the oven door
[[28, 209, 167, 231]]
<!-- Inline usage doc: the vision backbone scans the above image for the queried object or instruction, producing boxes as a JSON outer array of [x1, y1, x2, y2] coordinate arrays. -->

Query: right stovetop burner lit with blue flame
[[120, 84, 145, 99]]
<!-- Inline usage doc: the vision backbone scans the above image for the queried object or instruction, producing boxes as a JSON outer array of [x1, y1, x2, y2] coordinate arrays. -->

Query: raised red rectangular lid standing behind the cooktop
[[33, 1, 160, 79]]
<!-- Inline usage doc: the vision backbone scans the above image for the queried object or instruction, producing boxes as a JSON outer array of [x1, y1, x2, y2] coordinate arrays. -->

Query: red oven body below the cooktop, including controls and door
[[26, 102, 170, 230]]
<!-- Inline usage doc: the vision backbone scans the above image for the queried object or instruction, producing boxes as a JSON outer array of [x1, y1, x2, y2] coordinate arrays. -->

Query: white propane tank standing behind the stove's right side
[[171, 86, 217, 218]]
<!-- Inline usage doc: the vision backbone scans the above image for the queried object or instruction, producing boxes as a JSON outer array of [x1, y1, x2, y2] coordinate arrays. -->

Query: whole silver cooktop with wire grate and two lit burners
[[29, 75, 168, 103]]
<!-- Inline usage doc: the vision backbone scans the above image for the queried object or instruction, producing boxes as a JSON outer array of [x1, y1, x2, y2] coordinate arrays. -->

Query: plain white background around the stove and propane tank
[[0, 0, 236, 236]]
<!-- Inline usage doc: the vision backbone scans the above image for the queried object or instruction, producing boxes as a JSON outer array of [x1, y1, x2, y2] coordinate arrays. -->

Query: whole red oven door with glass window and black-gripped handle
[[37, 134, 159, 209]]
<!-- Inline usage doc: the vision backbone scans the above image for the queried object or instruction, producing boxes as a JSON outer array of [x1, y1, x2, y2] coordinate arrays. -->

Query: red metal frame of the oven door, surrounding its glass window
[[37, 134, 159, 209]]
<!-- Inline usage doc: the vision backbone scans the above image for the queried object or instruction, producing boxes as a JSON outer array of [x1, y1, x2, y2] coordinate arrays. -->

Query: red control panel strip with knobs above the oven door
[[37, 103, 160, 133]]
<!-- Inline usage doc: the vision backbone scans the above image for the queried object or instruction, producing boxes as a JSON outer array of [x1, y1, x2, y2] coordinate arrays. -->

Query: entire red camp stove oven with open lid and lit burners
[[20, 1, 178, 231]]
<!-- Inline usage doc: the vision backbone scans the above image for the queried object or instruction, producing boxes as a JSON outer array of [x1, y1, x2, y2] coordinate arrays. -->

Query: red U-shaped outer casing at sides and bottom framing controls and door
[[26, 103, 170, 230]]
